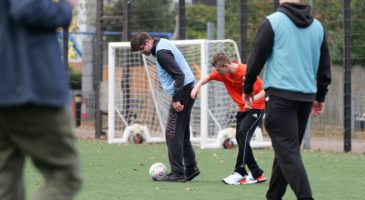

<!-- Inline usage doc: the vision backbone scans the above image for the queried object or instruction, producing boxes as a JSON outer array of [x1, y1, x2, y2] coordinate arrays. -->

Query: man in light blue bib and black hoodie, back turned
[[244, 0, 331, 200]]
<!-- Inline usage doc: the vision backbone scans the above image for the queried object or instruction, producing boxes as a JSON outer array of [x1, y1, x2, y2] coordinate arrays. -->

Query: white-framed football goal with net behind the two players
[[108, 40, 271, 148]]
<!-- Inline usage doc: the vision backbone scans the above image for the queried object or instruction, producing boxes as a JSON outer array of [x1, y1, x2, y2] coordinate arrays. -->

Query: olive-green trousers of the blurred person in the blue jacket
[[0, 105, 82, 200]]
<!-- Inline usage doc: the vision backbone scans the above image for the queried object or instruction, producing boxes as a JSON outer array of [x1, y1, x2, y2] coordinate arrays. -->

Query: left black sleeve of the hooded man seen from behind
[[244, 19, 274, 94]]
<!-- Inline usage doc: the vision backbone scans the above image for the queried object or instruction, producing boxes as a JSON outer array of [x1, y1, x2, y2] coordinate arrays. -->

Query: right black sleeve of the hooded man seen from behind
[[316, 34, 331, 102]]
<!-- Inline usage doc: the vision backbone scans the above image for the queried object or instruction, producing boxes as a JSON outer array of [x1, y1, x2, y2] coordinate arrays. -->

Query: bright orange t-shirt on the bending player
[[209, 64, 265, 112]]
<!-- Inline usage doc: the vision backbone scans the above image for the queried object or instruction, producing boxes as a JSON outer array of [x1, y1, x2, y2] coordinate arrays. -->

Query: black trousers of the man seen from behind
[[265, 96, 312, 200]]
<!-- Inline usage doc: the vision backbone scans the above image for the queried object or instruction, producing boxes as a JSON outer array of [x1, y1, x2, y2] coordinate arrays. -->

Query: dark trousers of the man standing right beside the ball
[[165, 84, 197, 174]]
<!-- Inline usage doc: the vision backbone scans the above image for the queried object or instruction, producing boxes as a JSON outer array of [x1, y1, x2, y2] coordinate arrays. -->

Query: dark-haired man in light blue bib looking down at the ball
[[131, 32, 200, 182]]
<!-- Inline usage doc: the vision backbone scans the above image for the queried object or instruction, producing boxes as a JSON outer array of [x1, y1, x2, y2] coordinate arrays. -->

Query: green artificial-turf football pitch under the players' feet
[[25, 140, 365, 200]]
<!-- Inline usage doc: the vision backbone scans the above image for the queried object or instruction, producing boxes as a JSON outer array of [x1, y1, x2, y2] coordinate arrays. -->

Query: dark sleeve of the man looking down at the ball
[[156, 49, 185, 102]]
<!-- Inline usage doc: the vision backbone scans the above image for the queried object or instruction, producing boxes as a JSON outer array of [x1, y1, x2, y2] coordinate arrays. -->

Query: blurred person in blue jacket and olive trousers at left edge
[[0, 0, 82, 200]]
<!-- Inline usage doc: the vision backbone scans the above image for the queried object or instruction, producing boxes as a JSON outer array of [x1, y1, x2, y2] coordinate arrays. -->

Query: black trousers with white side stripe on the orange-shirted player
[[235, 109, 263, 178]]
